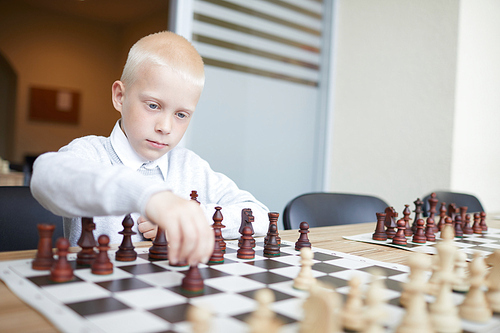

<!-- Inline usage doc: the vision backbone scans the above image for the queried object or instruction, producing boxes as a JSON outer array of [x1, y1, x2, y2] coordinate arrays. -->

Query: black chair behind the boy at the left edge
[[0, 186, 63, 251]]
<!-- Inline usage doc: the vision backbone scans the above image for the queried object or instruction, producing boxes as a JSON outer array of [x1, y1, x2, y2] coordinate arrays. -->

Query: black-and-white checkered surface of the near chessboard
[[0, 240, 500, 333]]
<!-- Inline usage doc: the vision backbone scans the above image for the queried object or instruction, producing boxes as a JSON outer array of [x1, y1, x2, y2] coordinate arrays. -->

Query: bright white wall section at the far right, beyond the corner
[[451, 0, 500, 212]]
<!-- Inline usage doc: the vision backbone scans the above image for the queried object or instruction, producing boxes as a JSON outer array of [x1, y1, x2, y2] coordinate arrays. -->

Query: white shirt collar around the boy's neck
[[110, 120, 168, 180]]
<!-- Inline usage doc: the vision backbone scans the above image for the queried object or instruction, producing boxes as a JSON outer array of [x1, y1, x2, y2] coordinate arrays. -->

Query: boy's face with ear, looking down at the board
[[113, 65, 202, 161]]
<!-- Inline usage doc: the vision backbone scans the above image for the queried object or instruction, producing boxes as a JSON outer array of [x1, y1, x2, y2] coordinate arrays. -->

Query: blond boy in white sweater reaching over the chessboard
[[31, 31, 268, 264]]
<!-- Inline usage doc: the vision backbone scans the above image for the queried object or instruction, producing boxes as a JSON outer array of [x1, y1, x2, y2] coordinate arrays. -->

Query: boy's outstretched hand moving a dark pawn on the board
[[146, 191, 215, 265]]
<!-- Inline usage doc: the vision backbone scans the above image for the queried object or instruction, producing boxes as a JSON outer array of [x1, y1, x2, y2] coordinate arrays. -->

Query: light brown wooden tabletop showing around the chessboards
[[0, 214, 500, 332]]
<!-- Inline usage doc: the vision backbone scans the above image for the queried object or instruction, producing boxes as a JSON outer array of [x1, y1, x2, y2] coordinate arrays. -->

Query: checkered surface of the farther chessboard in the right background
[[344, 228, 500, 261]]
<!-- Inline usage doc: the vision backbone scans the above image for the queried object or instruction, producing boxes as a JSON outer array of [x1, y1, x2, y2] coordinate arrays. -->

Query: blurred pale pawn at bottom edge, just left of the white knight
[[246, 288, 283, 333]]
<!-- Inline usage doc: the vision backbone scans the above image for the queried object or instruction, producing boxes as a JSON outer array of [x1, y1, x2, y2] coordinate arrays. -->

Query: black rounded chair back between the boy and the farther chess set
[[283, 192, 388, 230]]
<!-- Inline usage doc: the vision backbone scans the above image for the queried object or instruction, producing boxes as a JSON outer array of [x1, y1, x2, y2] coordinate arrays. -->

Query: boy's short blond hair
[[120, 31, 205, 87]]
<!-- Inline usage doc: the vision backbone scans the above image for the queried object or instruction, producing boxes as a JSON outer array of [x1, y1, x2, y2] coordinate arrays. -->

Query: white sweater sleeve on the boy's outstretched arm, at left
[[30, 137, 172, 217]]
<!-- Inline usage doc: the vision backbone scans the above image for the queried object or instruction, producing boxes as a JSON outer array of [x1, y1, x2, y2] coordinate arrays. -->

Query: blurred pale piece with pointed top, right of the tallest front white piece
[[460, 252, 493, 323]]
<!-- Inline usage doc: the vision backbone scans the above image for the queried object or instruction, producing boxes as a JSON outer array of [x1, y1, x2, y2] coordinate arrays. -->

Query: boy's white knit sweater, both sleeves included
[[31, 123, 269, 246]]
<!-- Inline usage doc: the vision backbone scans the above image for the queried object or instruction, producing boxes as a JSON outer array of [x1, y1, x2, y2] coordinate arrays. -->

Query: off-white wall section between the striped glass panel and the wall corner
[[327, 0, 459, 211]]
